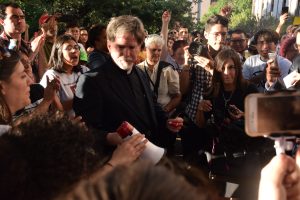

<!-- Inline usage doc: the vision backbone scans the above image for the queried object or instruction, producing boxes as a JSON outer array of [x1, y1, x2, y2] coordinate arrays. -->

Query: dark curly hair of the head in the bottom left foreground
[[0, 115, 101, 200]]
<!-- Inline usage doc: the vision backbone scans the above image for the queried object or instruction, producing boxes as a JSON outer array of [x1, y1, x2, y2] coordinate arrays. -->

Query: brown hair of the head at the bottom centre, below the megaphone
[[57, 161, 212, 200]]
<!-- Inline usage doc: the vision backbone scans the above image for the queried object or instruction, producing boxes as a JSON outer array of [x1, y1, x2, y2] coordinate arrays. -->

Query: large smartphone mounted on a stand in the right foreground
[[245, 91, 300, 137]]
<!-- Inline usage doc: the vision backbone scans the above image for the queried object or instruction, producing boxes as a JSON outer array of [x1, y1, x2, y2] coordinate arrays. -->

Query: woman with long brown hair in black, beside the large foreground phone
[[196, 49, 273, 199]]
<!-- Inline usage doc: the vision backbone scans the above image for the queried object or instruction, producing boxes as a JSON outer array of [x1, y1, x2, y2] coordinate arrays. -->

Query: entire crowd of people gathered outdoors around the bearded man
[[0, 3, 300, 200]]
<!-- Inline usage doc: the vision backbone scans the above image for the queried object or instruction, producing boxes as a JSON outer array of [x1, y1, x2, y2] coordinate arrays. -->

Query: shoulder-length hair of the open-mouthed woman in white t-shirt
[[48, 34, 81, 73]]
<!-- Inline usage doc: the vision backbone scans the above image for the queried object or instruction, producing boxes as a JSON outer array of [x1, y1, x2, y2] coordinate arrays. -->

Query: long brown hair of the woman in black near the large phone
[[205, 48, 248, 98]]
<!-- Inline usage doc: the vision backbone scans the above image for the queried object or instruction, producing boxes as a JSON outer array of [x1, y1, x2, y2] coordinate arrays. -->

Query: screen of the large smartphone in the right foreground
[[257, 96, 300, 133]]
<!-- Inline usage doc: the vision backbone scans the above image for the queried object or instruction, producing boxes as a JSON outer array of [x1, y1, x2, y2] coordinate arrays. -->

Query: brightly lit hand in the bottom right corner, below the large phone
[[258, 150, 300, 200]]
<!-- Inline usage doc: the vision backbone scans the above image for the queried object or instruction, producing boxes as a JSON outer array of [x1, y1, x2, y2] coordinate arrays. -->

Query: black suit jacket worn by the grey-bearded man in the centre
[[73, 58, 166, 143]]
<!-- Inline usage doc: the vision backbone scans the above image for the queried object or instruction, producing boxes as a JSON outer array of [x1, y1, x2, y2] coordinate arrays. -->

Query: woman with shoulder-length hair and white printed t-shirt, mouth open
[[40, 35, 88, 117]]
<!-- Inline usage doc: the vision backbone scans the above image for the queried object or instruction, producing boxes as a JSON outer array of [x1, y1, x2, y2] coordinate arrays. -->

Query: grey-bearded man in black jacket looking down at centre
[[73, 16, 183, 150]]
